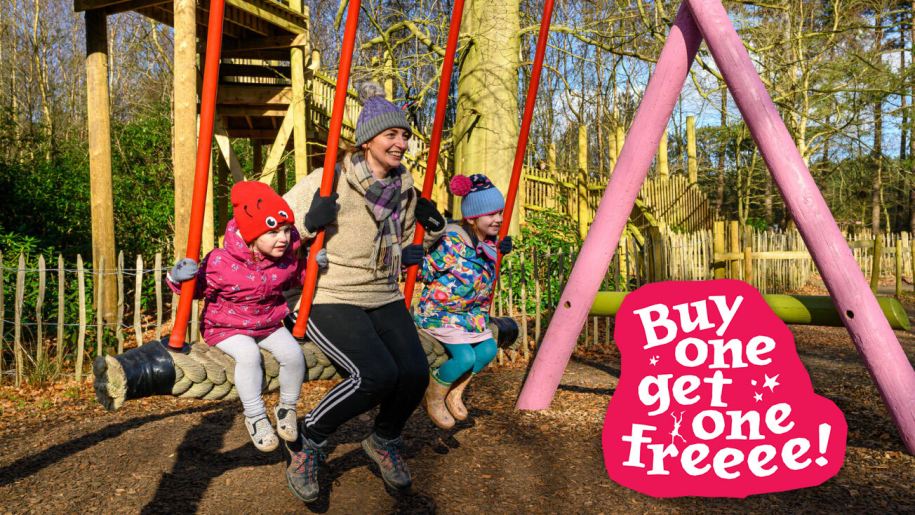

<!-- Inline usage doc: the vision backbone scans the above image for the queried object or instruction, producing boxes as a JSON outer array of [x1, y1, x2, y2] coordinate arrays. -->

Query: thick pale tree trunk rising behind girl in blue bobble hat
[[453, 0, 521, 233]]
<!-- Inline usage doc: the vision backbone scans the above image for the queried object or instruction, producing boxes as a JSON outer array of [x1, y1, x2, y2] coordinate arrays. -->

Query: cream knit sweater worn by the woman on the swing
[[283, 153, 444, 309]]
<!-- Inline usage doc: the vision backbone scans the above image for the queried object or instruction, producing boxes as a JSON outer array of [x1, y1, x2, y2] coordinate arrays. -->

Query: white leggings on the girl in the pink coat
[[216, 327, 305, 418]]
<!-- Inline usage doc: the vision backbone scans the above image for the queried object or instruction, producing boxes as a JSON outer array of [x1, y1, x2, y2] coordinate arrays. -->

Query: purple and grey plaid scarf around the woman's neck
[[346, 154, 409, 283]]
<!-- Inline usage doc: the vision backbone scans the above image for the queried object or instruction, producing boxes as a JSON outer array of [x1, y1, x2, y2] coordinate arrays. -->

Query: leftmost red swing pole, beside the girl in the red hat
[[168, 0, 225, 350]]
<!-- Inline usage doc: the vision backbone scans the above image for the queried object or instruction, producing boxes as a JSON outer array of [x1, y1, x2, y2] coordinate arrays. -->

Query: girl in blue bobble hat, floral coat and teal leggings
[[415, 174, 512, 429]]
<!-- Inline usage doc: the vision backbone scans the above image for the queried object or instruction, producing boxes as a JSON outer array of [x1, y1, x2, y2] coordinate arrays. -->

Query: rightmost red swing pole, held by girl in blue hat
[[496, 0, 553, 279]]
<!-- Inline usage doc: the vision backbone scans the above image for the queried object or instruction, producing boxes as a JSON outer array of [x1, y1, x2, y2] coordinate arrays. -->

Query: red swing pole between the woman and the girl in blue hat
[[403, 0, 464, 309]]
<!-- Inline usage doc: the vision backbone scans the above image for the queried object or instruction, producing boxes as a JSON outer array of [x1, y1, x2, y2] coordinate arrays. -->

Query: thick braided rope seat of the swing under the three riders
[[93, 324, 520, 411]]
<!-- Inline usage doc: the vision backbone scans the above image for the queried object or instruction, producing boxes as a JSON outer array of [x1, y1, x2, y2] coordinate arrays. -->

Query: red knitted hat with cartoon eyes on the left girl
[[231, 181, 295, 243]]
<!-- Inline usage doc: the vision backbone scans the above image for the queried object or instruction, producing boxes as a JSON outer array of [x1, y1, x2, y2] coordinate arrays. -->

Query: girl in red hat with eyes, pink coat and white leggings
[[168, 181, 318, 452]]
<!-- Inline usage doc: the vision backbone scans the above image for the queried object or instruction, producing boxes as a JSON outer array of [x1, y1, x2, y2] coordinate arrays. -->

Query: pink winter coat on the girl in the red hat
[[167, 220, 305, 346]]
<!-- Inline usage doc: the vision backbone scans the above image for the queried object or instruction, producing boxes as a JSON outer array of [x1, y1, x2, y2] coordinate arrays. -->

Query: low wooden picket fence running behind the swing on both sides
[[0, 227, 913, 384]]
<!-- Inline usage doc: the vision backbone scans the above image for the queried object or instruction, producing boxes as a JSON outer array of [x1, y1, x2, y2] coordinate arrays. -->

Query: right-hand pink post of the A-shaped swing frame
[[687, 0, 915, 454]]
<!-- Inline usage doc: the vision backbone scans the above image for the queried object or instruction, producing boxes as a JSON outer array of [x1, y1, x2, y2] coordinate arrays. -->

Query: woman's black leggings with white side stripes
[[302, 300, 429, 443]]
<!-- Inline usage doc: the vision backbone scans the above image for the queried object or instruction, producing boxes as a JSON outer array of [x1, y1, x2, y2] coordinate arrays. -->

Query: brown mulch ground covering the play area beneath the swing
[[0, 299, 915, 513]]
